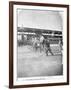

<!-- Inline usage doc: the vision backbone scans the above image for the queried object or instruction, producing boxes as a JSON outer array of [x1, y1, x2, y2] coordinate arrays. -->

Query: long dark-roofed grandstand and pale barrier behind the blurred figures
[[17, 27, 63, 54]]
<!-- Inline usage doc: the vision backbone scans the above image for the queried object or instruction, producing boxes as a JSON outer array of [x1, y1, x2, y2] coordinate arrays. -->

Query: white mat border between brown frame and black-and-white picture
[[13, 5, 67, 85]]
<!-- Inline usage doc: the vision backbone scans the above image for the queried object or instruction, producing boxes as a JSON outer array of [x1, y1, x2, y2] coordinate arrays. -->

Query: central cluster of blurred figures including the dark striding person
[[32, 35, 53, 55]]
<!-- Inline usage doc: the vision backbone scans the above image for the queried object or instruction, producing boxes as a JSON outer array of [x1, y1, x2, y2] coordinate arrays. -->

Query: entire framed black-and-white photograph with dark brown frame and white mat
[[9, 2, 69, 88]]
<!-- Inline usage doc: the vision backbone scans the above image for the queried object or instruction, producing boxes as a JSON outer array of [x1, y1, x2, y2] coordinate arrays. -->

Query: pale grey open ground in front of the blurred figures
[[17, 46, 63, 77]]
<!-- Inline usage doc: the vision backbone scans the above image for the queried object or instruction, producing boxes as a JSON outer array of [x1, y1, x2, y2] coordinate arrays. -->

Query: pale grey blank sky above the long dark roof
[[17, 9, 63, 31]]
